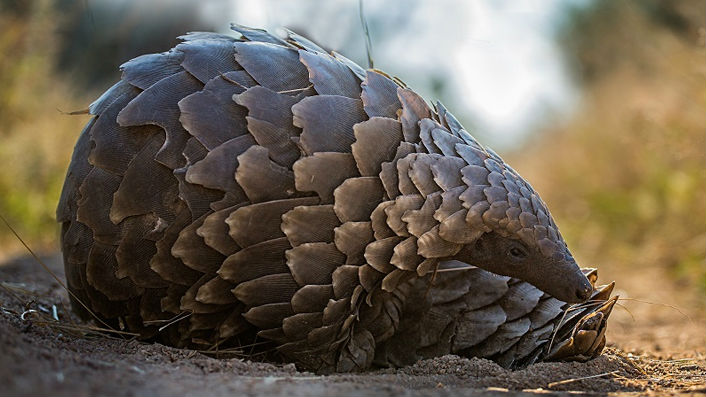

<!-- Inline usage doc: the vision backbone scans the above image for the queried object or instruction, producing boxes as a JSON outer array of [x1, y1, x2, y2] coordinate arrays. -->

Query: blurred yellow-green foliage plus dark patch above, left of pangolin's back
[[0, 0, 213, 252]]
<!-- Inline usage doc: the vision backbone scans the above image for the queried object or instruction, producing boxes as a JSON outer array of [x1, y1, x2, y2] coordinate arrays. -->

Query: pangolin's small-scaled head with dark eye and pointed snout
[[441, 147, 592, 303]]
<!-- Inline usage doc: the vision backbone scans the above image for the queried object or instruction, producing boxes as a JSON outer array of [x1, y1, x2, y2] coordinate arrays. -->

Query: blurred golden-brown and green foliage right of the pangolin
[[512, 0, 706, 288]]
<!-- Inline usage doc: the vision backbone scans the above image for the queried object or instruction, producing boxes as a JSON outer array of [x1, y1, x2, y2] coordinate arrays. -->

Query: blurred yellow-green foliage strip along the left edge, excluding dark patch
[[0, 1, 87, 251]]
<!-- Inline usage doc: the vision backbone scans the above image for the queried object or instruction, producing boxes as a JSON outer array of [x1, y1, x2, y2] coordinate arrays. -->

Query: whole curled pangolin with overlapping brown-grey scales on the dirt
[[57, 26, 616, 373]]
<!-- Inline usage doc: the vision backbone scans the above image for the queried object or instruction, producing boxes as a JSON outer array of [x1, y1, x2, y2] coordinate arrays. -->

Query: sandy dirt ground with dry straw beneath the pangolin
[[0, 255, 706, 396]]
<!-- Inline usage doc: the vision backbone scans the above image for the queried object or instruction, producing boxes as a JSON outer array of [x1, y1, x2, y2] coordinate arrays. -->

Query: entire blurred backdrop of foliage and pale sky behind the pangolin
[[0, 0, 706, 351]]
